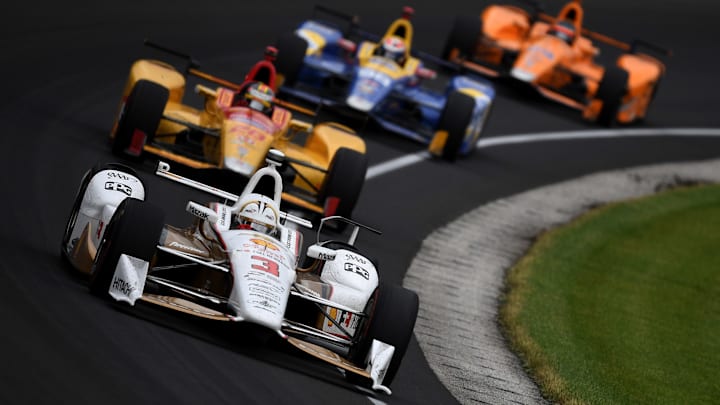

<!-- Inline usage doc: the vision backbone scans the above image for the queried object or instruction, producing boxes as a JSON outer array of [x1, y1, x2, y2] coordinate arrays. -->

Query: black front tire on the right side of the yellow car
[[318, 148, 368, 218]]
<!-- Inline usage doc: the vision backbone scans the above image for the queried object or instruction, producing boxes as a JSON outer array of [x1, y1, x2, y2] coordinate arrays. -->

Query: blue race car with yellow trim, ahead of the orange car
[[277, 6, 495, 161]]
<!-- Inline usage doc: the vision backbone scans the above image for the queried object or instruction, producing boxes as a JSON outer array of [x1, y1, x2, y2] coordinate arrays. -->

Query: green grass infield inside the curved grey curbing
[[501, 186, 720, 404]]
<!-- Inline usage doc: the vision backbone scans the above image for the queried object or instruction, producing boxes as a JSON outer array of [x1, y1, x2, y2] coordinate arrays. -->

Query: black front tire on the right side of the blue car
[[438, 91, 475, 162]]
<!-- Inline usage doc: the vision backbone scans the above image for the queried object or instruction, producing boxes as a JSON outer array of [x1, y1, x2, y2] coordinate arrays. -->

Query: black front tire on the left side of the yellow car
[[112, 79, 170, 160]]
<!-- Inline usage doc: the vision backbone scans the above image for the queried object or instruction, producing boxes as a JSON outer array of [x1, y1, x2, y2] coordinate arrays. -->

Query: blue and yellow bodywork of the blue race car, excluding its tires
[[280, 20, 495, 155]]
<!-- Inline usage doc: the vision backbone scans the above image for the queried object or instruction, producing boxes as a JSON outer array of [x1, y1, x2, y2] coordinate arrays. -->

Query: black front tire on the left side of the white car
[[89, 198, 165, 298]]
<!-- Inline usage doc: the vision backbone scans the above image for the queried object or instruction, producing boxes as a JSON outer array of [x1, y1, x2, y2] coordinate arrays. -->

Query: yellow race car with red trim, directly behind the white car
[[110, 42, 367, 221]]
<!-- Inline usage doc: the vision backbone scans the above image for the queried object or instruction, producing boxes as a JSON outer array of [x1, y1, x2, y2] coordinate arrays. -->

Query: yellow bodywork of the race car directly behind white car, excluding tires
[[111, 60, 365, 212]]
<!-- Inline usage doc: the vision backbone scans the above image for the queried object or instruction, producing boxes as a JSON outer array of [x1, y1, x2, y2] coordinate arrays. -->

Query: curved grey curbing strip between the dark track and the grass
[[404, 159, 720, 404]]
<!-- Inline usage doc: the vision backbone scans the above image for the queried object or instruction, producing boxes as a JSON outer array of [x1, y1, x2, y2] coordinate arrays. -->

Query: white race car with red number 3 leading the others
[[61, 154, 418, 394]]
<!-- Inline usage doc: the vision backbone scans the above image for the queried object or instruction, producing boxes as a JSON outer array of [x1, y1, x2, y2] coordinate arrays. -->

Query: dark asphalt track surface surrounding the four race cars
[[0, 0, 720, 404]]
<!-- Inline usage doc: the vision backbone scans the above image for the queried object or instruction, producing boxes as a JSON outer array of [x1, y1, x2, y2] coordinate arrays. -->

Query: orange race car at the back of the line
[[442, 0, 670, 125]]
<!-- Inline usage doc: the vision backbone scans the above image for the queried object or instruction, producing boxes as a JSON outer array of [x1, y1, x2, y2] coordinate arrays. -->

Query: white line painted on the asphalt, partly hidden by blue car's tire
[[365, 128, 720, 180]]
